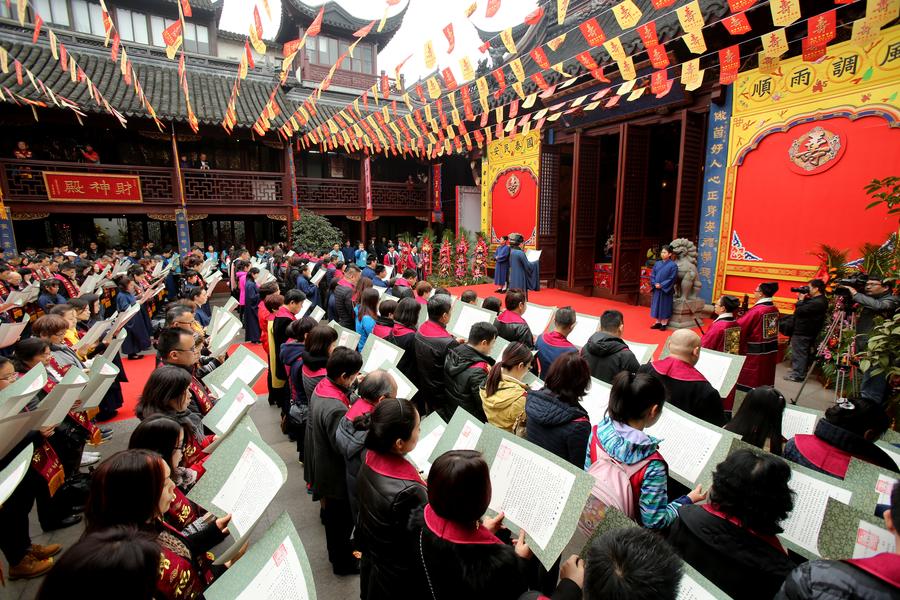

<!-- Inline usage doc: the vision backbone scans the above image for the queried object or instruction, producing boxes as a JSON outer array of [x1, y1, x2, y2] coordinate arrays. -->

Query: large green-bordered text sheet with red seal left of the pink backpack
[[477, 425, 594, 569]]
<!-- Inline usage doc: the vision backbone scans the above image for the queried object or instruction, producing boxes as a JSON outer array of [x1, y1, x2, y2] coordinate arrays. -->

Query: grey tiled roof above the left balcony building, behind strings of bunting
[[0, 37, 293, 127]]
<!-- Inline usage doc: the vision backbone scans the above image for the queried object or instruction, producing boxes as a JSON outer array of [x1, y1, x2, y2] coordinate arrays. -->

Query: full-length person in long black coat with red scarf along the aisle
[[303, 346, 362, 575]]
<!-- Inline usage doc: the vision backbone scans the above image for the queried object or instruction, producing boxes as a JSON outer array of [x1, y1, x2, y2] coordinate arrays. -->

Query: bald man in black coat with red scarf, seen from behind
[[638, 329, 725, 427]]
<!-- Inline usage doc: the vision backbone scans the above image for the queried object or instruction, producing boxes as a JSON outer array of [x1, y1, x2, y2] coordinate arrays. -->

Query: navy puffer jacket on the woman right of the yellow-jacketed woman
[[525, 388, 591, 467]]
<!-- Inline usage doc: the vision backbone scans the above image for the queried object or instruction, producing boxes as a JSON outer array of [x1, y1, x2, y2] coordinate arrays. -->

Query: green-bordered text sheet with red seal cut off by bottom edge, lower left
[[203, 512, 316, 600]]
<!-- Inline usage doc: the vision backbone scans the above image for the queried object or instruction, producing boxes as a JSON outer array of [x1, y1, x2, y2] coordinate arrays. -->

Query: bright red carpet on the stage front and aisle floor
[[113, 284, 709, 421]]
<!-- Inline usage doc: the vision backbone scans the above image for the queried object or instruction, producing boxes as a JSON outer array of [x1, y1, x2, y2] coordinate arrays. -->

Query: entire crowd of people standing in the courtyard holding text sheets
[[0, 240, 900, 600]]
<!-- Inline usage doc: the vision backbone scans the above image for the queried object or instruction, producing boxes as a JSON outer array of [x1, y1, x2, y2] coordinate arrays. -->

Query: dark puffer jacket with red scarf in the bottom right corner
[[775, 554, 900, 600]]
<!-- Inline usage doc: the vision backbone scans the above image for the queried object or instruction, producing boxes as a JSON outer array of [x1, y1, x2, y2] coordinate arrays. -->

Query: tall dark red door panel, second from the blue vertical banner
[[612, 123, 650, 301]]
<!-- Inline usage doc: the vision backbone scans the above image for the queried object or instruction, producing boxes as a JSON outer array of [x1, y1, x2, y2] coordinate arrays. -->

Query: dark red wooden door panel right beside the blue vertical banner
[[672, 110, 706, 240]]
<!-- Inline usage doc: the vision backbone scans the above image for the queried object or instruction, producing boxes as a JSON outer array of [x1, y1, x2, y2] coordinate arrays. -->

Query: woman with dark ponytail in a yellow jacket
[[472, 342, 534, 433]]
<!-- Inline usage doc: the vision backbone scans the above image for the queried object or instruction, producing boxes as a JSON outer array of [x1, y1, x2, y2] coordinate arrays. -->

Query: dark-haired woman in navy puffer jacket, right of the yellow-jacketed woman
[[525, 352, 591, 467]]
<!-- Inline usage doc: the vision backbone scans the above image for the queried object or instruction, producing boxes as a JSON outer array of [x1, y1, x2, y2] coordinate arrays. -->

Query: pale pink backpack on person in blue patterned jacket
[[588, 427, 665, 523]]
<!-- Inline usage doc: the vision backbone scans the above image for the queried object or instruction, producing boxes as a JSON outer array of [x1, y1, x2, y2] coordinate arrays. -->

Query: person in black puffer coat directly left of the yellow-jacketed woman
[[441, 323, 497, 423]]
